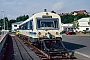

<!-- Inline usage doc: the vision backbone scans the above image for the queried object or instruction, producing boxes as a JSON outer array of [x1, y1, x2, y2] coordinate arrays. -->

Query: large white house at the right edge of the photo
[[77, 17, 90, 31]]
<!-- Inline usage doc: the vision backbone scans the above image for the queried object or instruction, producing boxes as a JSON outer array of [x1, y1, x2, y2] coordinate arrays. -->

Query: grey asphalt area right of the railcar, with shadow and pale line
[[63, 35, 90, 60]]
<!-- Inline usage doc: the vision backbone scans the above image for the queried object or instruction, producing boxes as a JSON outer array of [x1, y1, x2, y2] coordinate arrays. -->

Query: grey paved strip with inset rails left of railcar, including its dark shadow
[[4, 35, 40, 60]]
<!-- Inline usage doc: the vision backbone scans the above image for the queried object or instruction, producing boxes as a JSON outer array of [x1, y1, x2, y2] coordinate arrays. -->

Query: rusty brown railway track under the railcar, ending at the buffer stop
[[16, 36, 76, 60]]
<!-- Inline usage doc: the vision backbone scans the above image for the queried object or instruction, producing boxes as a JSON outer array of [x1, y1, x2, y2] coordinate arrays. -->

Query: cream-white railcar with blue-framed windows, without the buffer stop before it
[[19, 12, 62, 42]]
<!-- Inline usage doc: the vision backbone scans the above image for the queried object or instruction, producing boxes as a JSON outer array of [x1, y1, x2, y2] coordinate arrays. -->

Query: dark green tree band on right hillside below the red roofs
[[61, 14, 90, 24]]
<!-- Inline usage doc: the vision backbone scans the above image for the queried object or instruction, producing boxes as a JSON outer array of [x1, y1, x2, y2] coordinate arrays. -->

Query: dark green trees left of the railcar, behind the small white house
[[0, 15, 29, 30]]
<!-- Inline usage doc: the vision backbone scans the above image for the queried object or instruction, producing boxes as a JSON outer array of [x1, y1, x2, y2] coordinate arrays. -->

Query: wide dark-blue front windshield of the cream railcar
[[37, 18, 59, 29]]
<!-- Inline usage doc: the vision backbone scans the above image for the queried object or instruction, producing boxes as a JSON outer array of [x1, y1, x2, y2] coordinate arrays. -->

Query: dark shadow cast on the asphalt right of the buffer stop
[[63, 41, 86, 50]]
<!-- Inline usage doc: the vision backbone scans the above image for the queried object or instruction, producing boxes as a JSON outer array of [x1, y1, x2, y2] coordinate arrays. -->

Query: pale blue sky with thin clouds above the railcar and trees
[[0, 0, 90, 19]]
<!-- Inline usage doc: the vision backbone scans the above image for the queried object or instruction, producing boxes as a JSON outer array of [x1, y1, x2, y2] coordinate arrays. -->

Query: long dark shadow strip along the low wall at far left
[[3, 35, 14, 60]]
